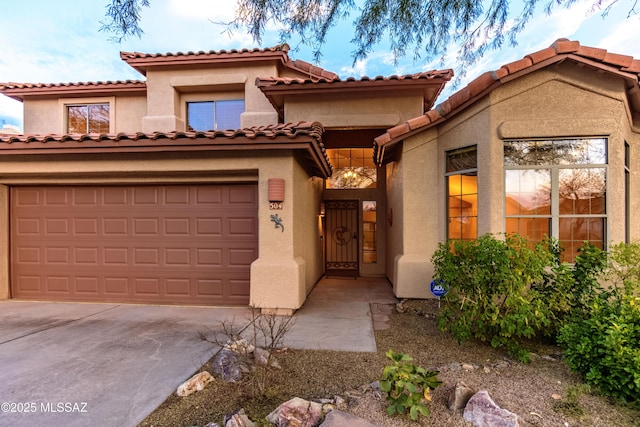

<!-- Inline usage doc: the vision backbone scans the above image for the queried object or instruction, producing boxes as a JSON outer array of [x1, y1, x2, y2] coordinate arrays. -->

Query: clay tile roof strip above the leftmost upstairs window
[[0, 80, 147, 101]]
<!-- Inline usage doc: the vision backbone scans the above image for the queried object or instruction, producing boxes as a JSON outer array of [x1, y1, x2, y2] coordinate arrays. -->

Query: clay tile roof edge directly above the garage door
[[0, 122, 332, 178]]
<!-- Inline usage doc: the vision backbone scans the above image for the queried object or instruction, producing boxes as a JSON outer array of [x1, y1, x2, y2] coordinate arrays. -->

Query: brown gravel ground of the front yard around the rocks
[[140, 300, 640, 427]]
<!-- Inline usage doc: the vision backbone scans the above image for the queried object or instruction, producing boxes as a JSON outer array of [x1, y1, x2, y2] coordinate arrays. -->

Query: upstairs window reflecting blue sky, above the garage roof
[[187, 99, 244, 131]]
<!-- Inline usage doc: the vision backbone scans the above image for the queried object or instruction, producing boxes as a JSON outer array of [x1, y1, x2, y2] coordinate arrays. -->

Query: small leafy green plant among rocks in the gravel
[[380, 350, 442, 421]]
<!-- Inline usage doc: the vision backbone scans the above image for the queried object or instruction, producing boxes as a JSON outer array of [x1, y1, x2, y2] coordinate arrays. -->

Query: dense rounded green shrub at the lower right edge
[[558, 295, 640, 403]]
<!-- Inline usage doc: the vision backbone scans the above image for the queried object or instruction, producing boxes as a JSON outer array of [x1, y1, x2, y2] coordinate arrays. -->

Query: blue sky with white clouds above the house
[[0, 0, 640, 128]]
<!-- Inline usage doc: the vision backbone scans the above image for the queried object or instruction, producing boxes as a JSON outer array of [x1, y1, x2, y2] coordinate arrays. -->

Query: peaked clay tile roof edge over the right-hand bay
[[373, 39, 640, 164]]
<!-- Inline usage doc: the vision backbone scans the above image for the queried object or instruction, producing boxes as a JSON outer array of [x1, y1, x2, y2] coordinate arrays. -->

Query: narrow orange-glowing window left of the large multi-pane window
[[446, 146, 478, 240]]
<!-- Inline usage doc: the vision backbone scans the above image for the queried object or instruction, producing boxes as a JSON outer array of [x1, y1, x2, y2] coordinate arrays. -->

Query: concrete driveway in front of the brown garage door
[[0, 301, 250, 427]]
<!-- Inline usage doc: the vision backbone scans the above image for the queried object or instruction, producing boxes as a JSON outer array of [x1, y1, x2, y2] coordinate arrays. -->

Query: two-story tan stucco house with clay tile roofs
[[0, 39, 640, 313]]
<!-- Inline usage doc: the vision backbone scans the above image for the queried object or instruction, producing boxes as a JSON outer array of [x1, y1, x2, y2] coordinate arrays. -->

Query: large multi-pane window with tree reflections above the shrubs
[[504, 138, 607, 262]]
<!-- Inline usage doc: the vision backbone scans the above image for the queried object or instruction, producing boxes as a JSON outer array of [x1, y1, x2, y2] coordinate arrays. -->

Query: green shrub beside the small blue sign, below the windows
[[431, 234, 555, 362]]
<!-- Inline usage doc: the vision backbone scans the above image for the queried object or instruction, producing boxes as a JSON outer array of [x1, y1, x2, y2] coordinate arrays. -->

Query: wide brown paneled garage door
[[11, 185, 258, 305]]
